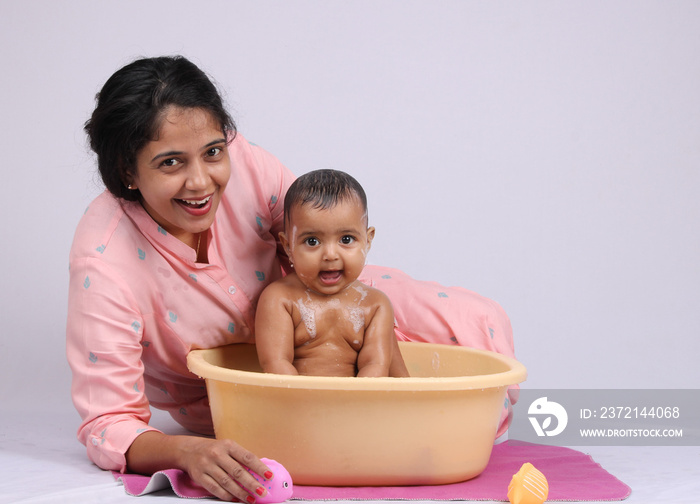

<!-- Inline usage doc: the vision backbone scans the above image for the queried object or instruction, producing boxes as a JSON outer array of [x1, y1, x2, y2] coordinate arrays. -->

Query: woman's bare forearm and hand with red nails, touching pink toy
[[126, 431, 272, 504]]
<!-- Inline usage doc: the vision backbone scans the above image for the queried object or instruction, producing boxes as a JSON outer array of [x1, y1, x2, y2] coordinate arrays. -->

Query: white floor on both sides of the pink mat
[[0, 405, 700, 504]]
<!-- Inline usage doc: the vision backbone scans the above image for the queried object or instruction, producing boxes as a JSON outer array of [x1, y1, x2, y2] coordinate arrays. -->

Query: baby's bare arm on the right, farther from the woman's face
[[357, 291, 396, 376]]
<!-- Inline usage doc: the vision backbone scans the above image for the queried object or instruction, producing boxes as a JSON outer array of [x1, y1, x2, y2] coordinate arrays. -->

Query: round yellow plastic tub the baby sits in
[[187, 343, 527, 486]]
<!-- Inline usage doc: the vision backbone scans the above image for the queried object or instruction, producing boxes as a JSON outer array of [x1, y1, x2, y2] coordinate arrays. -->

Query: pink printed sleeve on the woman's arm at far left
[[66, 257, 155, 472]]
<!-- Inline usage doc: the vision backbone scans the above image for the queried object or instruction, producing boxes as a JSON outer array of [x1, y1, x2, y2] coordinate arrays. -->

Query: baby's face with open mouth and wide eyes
[[281, 198, 374, 295]]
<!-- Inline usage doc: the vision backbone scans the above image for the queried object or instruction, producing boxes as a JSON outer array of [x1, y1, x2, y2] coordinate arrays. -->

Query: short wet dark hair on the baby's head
[[284, 170, 367, 224]]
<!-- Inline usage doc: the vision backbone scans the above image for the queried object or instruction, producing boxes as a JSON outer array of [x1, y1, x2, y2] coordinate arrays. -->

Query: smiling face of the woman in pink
[[129, 107, 231, 246]]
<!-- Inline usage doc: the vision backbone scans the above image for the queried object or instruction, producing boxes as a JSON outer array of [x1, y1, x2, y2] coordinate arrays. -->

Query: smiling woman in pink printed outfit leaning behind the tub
[[67, 57, 513, 502]]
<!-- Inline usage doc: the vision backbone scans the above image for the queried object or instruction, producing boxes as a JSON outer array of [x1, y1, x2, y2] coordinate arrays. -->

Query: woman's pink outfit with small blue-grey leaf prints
[[67, 134, 513, 471]]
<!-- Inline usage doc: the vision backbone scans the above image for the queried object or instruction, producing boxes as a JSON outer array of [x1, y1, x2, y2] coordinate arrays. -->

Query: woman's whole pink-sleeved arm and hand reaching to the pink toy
[[67, 258, 268, 502]]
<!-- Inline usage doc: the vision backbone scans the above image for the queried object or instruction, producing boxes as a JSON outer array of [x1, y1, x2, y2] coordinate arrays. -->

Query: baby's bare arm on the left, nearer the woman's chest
[[255, 282, 299, 375]]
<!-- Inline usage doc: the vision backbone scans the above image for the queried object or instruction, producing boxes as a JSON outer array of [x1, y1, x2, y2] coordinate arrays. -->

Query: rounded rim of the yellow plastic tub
[[187, 342, 527, 392]]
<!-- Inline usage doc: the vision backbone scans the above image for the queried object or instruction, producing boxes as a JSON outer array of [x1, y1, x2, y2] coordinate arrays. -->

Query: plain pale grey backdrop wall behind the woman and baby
[[0, 0, 700, 418]]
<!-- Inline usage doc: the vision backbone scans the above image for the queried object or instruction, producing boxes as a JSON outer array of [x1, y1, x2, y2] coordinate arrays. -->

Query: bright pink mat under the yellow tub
[[114, 440, 632, 501]]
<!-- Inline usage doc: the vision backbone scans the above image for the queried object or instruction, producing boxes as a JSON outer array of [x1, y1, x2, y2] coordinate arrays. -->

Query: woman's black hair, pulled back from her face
[[85, 56, 236, 201]]
